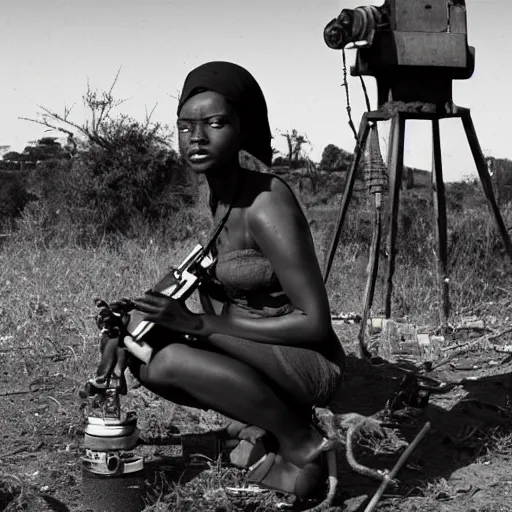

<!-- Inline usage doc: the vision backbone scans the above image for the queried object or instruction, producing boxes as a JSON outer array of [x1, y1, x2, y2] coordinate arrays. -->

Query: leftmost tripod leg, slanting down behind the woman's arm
[[324, 114, 370, 282]]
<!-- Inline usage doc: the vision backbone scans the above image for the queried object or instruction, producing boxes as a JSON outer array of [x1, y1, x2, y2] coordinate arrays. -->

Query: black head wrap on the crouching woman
[[178, 61, 272, 166]]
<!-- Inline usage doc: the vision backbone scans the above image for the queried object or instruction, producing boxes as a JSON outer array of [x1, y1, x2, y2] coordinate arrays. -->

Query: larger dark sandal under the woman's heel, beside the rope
[[247, 438, 337, 501]]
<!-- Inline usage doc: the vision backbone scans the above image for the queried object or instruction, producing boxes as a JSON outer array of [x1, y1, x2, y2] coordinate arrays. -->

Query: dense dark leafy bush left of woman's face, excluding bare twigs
[[25, 117, 197, 244]]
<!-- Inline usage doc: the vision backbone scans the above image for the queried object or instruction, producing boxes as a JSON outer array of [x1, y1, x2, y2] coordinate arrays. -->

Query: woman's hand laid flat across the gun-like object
[[133, 292, 204, 336]]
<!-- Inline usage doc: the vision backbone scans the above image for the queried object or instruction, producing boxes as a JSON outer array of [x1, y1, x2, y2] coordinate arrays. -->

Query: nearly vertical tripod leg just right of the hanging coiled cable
[[384, 113, 405, 318]]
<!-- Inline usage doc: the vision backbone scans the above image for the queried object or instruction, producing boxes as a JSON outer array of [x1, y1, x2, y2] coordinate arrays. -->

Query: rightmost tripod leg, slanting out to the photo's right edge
[[461, 110, 512, 261]]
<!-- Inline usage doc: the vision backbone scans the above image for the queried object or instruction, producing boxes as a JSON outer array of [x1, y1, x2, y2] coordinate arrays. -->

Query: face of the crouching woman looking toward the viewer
[[178, 91, 240, 173]]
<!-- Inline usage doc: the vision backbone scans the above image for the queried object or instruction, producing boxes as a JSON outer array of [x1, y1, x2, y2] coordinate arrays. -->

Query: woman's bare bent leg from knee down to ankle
[[132, 343, 322, 466]]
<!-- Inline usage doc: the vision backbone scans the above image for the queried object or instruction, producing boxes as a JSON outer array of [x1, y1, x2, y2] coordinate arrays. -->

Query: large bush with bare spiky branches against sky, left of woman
[[21, 70, 197, 242]]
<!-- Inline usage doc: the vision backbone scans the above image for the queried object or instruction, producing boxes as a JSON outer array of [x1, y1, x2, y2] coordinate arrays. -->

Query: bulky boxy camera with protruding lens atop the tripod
[[324, 0, 475, 107]]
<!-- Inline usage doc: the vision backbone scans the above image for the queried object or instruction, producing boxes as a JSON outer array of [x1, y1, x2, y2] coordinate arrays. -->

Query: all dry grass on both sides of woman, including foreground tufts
[[0, 178, 512, 512]]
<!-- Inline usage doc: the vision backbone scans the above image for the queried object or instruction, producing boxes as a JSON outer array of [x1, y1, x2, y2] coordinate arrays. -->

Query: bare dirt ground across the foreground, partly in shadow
[[0, 322, 512, 512]]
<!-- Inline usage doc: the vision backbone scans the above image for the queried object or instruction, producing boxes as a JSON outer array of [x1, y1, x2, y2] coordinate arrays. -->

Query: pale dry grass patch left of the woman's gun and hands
[[0, 230, 204, 386]]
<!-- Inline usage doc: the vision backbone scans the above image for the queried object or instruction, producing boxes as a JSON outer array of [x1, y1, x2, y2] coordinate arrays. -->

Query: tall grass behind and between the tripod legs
[[306, 191, 512, 325]]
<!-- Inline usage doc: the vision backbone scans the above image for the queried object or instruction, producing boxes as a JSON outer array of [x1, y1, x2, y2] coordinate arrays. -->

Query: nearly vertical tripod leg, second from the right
[[432, 119, 450, 330]]
